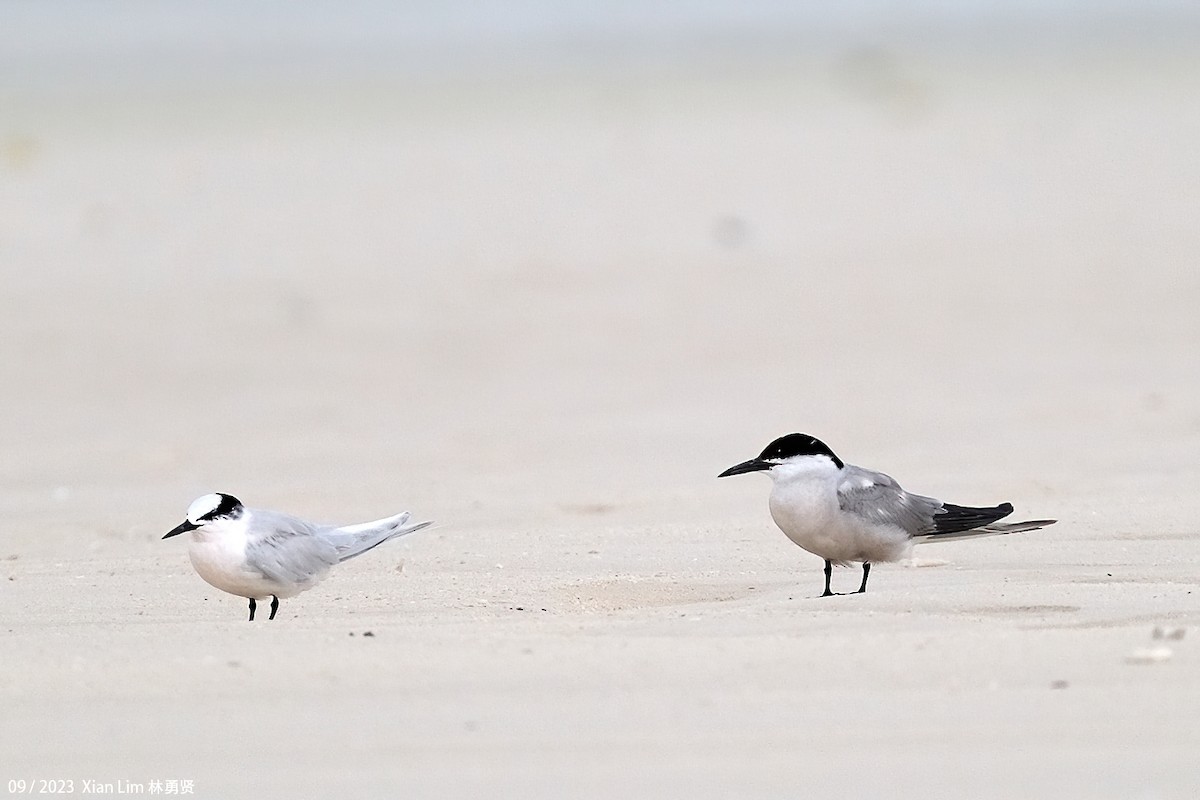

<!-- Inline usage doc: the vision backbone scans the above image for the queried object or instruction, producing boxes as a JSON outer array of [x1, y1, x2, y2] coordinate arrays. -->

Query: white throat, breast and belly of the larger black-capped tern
[[767, 456, 912, 565]]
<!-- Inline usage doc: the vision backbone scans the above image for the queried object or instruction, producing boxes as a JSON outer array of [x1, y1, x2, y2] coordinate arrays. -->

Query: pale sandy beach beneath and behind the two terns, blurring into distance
[[0, 9, 1200, 799]]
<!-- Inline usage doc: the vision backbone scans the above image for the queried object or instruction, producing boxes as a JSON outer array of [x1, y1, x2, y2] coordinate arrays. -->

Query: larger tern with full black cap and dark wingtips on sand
[[718, 433, 1056, 597]]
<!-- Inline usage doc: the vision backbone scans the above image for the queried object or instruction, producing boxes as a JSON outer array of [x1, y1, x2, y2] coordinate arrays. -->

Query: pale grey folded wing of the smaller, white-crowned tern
[[246, 511, 338, 584]]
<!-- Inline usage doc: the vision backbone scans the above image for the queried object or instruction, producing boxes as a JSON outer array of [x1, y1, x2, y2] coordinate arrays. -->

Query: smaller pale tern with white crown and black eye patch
[[163, 494, 431, 621]]
